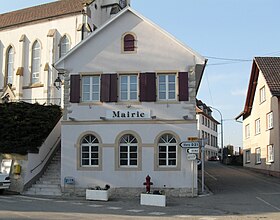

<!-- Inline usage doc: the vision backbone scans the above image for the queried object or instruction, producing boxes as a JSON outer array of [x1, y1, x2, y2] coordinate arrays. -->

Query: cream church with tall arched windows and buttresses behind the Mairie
[[0, 0, 129, 105]]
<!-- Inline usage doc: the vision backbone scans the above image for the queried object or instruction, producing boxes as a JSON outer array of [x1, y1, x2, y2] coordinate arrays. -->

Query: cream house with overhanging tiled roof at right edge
[[237, 57, 280, 176]]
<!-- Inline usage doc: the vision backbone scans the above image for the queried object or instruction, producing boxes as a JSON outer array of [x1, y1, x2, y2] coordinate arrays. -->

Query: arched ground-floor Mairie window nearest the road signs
[[158, 134, 177, 167]]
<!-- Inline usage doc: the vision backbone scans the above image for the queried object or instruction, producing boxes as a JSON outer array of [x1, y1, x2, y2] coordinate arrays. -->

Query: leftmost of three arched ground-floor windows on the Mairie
[[81, 135, 99, 167]]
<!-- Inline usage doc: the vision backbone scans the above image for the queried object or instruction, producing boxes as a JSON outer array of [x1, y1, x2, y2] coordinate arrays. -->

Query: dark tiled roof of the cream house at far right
[[255, 57, 280, 96]]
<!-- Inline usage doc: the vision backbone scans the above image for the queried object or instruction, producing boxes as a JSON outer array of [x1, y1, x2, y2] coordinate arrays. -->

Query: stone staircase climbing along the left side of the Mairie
[[23, 147, 62, 196]]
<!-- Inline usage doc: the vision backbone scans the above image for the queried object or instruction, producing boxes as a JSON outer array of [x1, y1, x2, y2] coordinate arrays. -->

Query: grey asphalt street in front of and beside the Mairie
[[0, 162, 280, 220]]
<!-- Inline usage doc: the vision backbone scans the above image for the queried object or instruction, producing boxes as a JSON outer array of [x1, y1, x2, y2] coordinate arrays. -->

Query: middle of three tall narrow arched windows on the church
[[31, 40, 41, 84]]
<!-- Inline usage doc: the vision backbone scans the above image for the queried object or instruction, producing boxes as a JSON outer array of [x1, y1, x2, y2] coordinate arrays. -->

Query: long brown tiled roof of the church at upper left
[[0, 0, 94, 30]]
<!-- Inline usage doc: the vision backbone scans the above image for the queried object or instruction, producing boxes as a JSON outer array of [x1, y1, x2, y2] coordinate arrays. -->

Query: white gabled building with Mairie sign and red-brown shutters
[[54, 7, 206, 196]]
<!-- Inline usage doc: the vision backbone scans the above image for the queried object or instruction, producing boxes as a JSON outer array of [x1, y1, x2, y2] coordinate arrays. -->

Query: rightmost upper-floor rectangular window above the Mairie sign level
[[158, 74, 176, 100]]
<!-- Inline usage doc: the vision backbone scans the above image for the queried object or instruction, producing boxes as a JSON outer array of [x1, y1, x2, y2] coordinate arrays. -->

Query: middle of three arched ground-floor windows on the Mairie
[[119, 134, 138, 167]]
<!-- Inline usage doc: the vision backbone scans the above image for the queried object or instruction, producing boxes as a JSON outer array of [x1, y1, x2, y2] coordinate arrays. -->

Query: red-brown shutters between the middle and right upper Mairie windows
[[139, 72, 156, 102]]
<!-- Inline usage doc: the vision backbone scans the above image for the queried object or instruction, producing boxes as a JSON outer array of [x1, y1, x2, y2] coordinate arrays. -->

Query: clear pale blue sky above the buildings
[[0, 0, 280, 150]]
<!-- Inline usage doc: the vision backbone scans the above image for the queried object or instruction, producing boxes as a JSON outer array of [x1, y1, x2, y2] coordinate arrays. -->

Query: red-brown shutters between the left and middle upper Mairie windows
[[100, 74, 118, 102]]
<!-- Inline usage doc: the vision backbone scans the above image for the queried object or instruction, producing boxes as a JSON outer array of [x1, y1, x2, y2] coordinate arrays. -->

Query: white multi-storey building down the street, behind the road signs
[[196, 100, 220, 160]]
